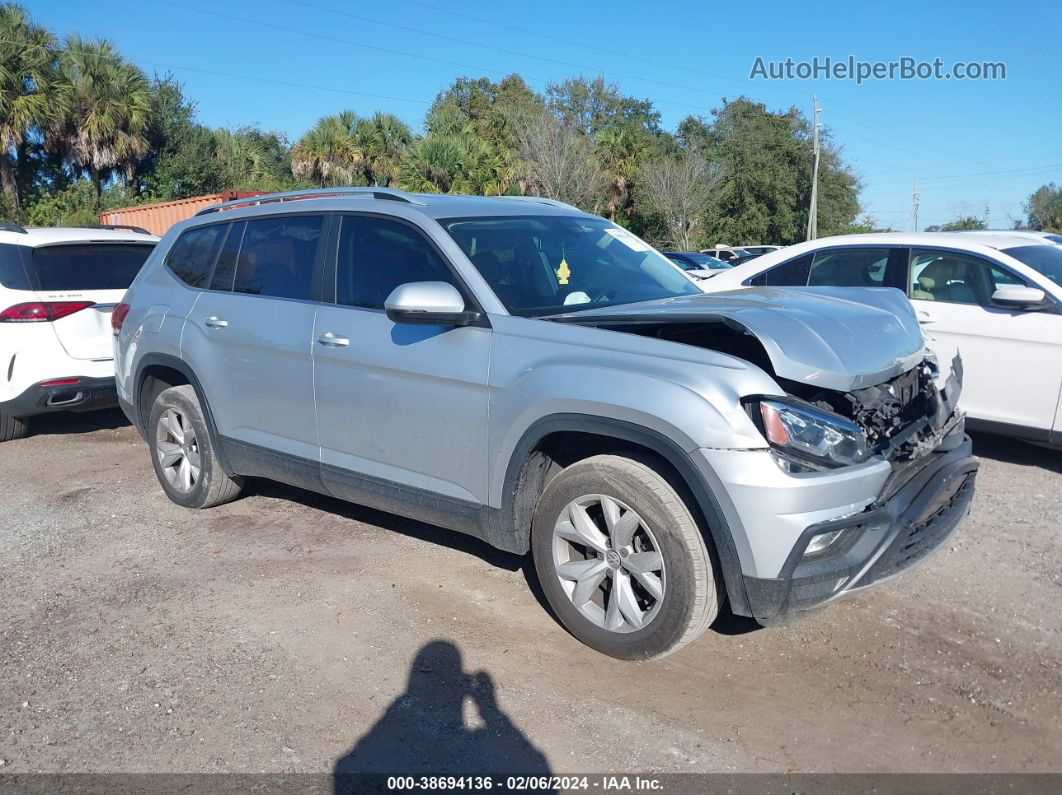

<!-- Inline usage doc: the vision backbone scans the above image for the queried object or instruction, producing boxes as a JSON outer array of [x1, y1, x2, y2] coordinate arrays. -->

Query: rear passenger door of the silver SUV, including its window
[[182, 213, 328, 458]]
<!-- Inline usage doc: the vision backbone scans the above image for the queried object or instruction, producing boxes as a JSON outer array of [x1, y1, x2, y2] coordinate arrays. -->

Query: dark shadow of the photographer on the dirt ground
[[333, 640, 550, 793]]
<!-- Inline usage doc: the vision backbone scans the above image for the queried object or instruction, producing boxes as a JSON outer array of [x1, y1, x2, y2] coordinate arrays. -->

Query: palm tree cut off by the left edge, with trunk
[[0, 3, 55, 217]]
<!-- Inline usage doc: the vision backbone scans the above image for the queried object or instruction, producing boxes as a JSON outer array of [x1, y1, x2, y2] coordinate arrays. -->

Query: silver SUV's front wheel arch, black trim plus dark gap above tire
[[501, 414, 748, 615]]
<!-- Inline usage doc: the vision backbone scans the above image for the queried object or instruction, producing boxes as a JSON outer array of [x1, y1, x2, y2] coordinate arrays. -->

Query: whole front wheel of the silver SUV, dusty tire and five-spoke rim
[[531, 455, 720, 660]]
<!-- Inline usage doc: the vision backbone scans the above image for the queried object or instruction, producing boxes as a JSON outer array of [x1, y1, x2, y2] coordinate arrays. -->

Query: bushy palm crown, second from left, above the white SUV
[[49, 35, 151, 200]]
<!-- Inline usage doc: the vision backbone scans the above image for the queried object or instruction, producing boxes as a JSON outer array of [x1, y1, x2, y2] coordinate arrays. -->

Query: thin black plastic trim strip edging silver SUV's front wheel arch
[[500, 414, 751, 616]]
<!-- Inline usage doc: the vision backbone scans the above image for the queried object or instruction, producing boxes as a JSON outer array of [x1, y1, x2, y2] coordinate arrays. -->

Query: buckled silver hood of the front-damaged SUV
[[550, 287, 925, 392]]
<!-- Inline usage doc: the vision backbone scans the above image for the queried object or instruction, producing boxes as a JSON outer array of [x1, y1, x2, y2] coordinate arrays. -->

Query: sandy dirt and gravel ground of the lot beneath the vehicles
[[0, 412, 1062, 773]]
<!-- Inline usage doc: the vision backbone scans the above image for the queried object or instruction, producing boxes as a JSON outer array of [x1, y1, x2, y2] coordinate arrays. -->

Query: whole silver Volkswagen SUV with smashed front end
[[115, 189, 977, 659]]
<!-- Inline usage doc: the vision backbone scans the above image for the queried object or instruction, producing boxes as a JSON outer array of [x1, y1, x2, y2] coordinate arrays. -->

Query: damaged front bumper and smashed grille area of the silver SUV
[[698, 350, 977, 624]]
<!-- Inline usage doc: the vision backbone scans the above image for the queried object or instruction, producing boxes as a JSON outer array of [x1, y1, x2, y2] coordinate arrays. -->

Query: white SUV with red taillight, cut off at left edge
[[0, 223, 158, 442]]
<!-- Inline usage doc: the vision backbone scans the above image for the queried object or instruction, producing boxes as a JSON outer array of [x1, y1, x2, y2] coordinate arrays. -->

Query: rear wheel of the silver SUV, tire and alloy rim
[[148, 384, 243, 508]]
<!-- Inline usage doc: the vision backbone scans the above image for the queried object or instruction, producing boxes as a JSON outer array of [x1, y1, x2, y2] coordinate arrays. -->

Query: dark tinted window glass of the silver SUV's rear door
[[233, 215, 325, 300]]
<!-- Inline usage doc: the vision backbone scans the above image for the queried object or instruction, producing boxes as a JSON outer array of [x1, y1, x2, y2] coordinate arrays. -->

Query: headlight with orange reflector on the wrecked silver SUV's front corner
[[759, 400, 870, 471]]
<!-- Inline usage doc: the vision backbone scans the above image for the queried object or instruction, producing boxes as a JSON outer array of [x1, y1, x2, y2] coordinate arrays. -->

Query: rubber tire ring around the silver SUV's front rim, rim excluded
[[531, 456, 713, 660]]
